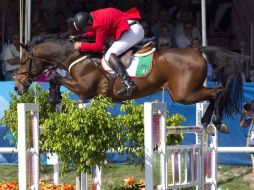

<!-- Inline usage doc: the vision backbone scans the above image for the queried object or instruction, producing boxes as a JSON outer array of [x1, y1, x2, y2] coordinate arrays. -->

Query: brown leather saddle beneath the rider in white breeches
[[119, 41, 155, 68]]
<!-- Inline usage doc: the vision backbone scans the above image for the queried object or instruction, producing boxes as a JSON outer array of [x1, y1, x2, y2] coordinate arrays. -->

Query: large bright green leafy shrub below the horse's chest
[[41, 97, 122, 173]]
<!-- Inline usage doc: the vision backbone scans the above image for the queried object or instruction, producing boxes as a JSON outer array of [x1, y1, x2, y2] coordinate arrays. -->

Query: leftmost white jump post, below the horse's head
[[18, 103, 39, 190]]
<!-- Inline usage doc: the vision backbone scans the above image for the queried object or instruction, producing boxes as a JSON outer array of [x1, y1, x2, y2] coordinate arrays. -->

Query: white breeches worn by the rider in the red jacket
[[105, 20, 144, 62]]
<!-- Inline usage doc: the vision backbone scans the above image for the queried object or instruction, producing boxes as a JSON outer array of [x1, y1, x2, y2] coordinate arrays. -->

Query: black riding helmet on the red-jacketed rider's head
[[74, 12, 91, 32]]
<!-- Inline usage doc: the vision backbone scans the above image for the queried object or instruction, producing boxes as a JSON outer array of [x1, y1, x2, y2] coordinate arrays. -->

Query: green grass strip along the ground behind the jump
[[0, 164, 254, 190]]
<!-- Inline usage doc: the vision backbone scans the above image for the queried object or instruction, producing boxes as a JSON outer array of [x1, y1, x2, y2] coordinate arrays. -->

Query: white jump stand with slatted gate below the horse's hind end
[[144, 102, 205, 190]]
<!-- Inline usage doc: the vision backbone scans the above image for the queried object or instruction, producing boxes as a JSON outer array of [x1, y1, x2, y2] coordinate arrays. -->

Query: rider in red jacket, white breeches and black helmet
[[74, 7, 144, 95]]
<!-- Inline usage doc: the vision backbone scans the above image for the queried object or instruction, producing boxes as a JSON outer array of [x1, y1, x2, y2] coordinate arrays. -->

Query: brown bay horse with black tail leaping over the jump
[[15, 39, 242, 135]]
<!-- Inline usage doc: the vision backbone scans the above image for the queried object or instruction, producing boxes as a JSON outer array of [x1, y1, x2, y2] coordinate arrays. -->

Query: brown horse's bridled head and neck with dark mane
[[15, 36, 80, 94]]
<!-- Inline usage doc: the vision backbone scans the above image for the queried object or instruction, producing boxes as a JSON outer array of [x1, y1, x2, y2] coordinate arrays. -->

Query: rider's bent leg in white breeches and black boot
[[105, 21, 144, 95]]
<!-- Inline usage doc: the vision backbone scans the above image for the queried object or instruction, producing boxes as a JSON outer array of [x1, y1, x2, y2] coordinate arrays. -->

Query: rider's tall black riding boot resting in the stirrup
[[109, 54, 137, 95]]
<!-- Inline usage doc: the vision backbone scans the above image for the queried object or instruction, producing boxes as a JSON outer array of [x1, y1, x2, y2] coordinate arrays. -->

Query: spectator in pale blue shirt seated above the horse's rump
[[175, 21, 198, 48]]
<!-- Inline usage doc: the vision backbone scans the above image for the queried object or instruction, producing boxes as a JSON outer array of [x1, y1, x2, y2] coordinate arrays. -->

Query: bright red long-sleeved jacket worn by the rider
[[80, 7, 141, 52]]
